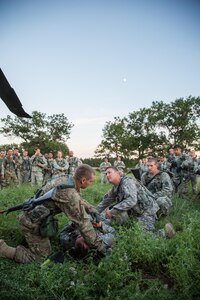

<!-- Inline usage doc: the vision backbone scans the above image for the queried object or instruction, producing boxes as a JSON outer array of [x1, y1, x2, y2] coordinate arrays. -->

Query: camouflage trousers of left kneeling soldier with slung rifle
[[14, 212, 51, 263]]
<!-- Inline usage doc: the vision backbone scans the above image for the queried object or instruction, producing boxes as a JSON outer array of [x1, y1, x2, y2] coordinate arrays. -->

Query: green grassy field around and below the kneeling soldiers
[[0, 178, 200, 300]]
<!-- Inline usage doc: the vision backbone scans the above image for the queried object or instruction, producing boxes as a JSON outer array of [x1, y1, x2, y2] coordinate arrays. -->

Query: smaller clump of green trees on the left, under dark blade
[[0, 111, 74, 143]]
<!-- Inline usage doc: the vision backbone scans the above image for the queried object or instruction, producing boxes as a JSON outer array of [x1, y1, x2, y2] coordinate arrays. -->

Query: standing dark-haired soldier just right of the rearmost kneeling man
[[171, 145, 193, 196]]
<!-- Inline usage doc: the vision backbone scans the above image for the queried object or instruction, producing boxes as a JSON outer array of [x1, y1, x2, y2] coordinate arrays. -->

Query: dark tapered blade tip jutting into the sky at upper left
[[0, 69, 31, 118]]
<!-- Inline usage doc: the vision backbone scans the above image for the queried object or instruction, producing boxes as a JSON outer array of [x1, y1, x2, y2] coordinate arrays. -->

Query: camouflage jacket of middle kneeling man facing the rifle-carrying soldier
[[97, 176, 159, 217]]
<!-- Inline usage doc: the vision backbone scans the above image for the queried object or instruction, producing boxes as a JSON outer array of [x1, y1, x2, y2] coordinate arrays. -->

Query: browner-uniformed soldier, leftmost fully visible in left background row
[[4, 148, 18, 186]]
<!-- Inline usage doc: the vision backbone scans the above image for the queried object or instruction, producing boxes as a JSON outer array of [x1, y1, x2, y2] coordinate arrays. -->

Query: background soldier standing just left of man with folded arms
[[20, 150, 31, 184]]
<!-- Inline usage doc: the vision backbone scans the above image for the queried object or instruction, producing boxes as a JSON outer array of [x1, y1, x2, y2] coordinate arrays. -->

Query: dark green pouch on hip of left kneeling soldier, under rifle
[[40, 214, 58, 238]]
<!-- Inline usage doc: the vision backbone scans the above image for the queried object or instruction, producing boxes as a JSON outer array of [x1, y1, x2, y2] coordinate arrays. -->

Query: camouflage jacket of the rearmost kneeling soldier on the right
[[141, 172, 173, 199]]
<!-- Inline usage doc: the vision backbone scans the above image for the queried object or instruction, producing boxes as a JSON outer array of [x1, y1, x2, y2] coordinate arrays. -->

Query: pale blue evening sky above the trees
[[0, 0, 200, 158]]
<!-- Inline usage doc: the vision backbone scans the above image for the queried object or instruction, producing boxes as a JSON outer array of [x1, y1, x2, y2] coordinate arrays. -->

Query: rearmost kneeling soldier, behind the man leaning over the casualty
[[141, 158, 173, 215]]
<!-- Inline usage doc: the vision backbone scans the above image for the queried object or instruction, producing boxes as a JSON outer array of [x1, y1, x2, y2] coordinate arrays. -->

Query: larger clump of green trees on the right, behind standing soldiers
[[95, 96, 200, 158]]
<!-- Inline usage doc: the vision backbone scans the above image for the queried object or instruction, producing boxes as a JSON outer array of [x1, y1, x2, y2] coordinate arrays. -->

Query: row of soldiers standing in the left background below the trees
[[0, 147, 82, 188]]
